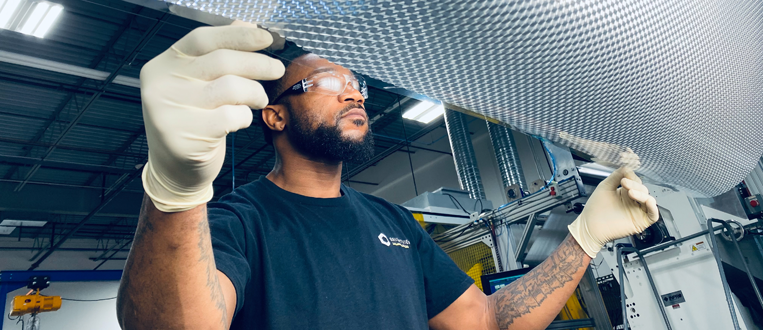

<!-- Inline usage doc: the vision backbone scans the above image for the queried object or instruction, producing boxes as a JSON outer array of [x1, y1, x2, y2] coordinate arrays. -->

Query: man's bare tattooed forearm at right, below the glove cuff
[[488, 235, 591, 330]]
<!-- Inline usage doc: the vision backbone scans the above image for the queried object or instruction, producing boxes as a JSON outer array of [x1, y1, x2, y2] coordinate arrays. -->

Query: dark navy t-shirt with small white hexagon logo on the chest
[[208, 177, 474, 330]]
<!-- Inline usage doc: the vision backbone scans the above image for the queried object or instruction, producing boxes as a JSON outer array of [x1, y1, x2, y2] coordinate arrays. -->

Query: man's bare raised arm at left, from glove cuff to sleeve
[[117, 197, 236, 329]]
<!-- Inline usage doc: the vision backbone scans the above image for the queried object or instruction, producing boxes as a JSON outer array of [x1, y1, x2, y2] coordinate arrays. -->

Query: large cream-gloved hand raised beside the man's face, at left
[[140, 22, 284, 212]]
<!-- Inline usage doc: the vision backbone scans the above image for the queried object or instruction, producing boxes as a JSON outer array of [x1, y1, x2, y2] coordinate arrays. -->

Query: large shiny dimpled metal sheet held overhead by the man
[[171, 0, 763, 196]]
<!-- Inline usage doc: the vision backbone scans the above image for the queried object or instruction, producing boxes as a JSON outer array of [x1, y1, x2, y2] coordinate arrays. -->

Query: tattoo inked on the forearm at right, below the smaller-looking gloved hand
[[490, 236, 585, 329]]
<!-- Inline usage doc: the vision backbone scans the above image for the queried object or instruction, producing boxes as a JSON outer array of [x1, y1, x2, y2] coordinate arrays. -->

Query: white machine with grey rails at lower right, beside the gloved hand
[[593, 184, 759, 330]]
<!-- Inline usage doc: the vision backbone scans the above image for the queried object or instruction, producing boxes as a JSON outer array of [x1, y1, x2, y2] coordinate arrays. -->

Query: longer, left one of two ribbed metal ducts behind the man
[[445, 109, 485, 199]]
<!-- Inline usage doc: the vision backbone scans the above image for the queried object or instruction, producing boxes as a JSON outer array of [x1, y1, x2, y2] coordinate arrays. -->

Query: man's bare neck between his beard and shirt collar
[[267, 150, 342, 198]]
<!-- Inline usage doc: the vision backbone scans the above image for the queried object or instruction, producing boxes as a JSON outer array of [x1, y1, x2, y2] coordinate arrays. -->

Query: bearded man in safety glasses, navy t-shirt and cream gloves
[[117, 24, 658, 329]]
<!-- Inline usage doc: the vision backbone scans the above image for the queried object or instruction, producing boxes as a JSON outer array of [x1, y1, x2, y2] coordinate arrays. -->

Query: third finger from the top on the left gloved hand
[[203, 75, 268, 109]]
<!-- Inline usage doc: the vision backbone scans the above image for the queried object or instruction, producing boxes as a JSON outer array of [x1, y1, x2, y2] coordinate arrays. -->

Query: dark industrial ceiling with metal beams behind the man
[[0, 0, 443, 264]]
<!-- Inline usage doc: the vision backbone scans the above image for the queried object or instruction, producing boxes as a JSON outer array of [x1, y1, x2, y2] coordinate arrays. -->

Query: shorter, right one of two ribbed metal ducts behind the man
[[487, 122, 527, 197]]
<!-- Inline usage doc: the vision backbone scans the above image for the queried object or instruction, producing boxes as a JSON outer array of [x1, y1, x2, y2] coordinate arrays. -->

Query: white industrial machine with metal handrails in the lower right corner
[[593, 178, 763, 330]]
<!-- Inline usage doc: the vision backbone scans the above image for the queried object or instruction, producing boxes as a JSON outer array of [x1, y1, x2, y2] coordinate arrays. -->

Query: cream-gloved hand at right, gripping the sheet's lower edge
[[568, 168, 660, 258]]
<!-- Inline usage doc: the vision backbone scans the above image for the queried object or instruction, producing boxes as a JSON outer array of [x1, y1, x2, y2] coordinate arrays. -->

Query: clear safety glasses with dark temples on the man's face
[[273, 72, 368, 104]]
